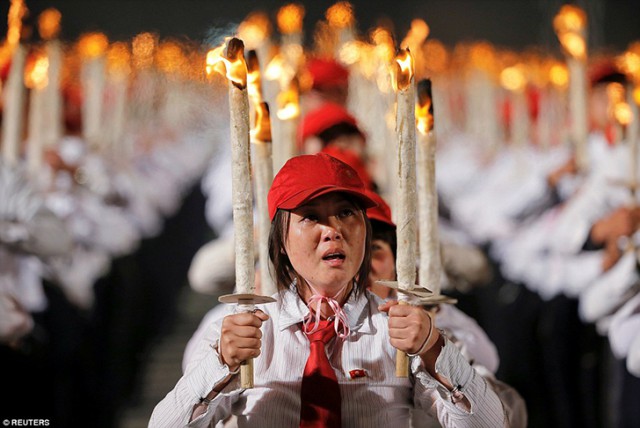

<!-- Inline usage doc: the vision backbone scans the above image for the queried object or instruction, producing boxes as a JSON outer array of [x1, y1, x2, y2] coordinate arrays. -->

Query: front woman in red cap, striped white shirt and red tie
[[149, 154, 506, 428]]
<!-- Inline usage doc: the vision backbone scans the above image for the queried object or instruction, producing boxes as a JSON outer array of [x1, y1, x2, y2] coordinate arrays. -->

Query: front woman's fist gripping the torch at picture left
[[218, 310, 269, 371]]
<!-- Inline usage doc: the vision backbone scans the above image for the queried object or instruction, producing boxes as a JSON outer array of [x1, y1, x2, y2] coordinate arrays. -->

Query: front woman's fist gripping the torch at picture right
[[378, 301, 437, 354]]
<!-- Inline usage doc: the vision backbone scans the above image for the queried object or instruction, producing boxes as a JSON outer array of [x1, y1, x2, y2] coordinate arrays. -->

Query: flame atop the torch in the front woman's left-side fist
[[206, 37, 247, 89]]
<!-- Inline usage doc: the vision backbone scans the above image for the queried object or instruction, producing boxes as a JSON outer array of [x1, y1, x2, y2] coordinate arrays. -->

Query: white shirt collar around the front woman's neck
[[278, 284, 376, 334]]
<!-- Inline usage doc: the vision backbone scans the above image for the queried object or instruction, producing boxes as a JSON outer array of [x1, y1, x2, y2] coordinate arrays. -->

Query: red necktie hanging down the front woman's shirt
[[300, 320, 342, 428]]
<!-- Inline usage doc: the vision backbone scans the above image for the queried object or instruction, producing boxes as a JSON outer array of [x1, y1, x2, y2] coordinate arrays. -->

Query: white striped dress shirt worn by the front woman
[[149, 289, 505, 428]]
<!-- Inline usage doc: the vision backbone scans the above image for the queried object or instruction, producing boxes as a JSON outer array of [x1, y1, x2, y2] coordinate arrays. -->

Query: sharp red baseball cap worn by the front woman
[[267, 153, 376, 220]]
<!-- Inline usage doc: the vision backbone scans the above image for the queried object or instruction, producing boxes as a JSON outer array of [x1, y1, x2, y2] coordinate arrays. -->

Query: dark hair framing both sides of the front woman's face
[[269, 196, 371, 294]]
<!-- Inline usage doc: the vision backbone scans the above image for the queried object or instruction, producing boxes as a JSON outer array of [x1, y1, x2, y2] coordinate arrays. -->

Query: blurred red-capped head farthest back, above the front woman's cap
[[302, 58, 349, 110]]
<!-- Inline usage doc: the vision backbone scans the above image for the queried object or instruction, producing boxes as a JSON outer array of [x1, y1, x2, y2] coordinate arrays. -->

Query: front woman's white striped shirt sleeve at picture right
[[411, 337, 506, 428]]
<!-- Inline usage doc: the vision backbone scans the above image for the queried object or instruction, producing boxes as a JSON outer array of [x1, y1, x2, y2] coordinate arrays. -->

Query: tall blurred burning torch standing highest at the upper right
[[553, 5, 589, 172]]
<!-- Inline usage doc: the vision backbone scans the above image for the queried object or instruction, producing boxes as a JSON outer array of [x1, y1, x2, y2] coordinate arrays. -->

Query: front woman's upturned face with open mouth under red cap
[[285, 192, 367, 296]]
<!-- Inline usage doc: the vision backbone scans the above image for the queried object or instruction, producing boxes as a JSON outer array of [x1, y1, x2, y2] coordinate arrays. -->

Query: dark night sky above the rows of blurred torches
[[0, 0, 640, 51]]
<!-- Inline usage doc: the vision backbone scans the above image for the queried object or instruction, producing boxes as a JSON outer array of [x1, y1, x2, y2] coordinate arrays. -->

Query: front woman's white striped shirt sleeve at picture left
[[149, 323, 243, 428]]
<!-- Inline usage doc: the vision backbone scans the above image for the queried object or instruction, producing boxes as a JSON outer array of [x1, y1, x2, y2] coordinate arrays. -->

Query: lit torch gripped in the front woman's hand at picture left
[[207, 38, 274, 388]]
